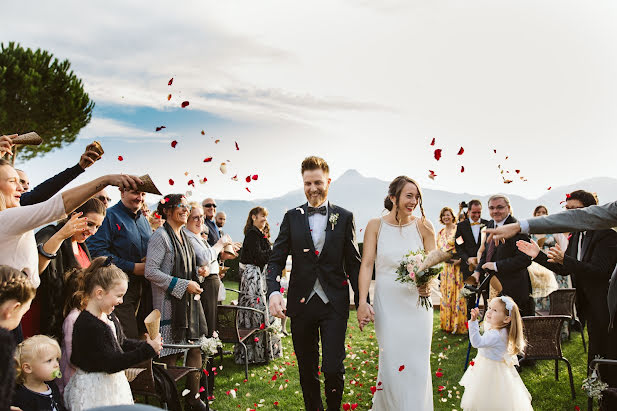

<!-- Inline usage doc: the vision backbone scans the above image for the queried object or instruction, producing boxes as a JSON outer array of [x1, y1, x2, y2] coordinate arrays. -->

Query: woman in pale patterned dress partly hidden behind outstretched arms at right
[[529, 205, 572, 311]]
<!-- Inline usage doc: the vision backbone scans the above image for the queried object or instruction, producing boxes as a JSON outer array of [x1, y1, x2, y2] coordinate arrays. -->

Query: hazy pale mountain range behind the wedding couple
[[218, 170, 617, 241]]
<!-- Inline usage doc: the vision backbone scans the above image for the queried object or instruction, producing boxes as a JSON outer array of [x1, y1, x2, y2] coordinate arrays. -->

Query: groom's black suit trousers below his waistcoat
[[291, 295, 347, 411]]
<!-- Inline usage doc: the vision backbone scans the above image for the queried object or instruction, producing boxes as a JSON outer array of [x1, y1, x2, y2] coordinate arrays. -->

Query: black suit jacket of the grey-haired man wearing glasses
[[478, 216, 533, 315]]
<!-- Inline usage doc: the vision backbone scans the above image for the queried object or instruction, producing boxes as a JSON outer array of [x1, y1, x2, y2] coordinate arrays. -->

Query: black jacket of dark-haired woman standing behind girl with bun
[[35, 224, 91, 340]]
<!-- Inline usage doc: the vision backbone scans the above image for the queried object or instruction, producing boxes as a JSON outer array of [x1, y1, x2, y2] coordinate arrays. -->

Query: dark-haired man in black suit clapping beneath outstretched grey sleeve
[[517, 190, 617, 387]]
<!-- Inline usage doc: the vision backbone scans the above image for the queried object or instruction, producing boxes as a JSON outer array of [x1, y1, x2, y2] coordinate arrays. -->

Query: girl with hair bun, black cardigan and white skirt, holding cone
[[64, 257, 162, 411]]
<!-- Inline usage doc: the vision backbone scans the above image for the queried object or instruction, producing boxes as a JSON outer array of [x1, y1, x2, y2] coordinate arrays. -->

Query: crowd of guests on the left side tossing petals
[[0, 136, 282, 411]]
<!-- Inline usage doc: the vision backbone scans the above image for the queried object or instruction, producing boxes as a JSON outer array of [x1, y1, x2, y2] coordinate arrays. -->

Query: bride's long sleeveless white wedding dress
[[372, 219, 433, 411]]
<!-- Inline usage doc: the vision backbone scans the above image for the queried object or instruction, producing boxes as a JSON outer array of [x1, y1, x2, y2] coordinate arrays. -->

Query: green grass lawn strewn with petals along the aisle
[[154, 282, 587, 411]]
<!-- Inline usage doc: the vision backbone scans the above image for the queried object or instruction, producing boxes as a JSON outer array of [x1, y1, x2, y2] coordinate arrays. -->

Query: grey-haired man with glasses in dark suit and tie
[[473, 194, 535, 316]]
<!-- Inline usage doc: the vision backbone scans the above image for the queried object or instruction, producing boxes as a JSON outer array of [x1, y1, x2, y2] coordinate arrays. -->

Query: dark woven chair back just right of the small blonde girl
[[523, 315, 569, 359]]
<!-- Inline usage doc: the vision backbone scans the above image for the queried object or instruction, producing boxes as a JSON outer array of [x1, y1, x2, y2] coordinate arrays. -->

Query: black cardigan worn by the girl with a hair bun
[[71, 310, 156, 374]]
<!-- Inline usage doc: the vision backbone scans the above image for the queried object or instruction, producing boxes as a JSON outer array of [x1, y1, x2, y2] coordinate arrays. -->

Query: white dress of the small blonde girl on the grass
[[460, 321, 533, 411]]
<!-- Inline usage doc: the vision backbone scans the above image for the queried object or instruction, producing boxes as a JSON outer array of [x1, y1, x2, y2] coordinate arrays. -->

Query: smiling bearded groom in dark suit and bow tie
[[267, 157, 360, 411]]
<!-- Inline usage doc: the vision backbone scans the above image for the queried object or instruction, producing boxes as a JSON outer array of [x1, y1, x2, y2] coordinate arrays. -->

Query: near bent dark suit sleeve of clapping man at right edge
[[563, 230, 617, 281]]
